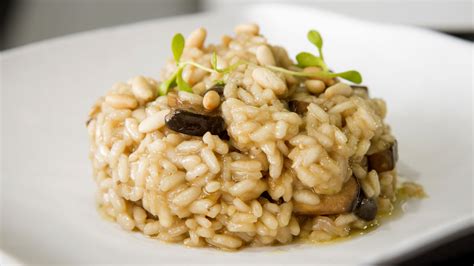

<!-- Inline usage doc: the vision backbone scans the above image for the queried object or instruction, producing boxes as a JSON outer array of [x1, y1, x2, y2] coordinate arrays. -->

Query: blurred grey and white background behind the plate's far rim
[[0, 0, 474, 50]]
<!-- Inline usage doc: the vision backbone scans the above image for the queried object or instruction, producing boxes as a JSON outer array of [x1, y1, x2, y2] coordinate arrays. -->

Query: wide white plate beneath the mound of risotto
[[0, 5, 473, 264]]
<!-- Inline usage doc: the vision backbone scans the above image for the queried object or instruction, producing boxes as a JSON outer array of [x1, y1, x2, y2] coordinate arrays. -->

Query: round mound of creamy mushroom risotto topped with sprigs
[[87, 24, 410, 250]]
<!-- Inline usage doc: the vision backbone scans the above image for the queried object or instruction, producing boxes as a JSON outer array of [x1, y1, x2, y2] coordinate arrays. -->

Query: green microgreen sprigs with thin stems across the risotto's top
[[158, 30, 362, 95]]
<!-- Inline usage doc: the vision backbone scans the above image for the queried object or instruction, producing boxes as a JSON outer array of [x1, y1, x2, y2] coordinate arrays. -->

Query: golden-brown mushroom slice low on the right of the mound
[[293, 177, 360, 215]]
